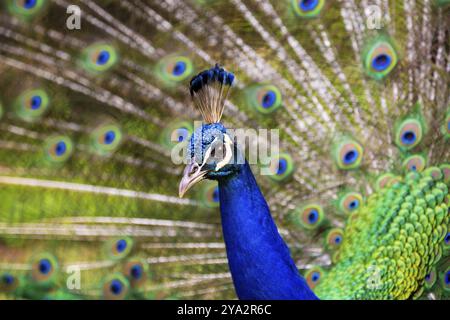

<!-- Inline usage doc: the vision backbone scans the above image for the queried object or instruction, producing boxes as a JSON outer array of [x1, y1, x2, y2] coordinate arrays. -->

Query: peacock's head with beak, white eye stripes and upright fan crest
[[179, 64, 239, 197]]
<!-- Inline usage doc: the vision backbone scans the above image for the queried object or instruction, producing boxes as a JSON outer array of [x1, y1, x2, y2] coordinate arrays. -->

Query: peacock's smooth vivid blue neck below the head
[[219, 163, 317, 300]]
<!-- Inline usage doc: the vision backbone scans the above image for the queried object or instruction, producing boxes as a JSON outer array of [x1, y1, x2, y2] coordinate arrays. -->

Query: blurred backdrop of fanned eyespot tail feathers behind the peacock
[[0, 0, 450, 299]]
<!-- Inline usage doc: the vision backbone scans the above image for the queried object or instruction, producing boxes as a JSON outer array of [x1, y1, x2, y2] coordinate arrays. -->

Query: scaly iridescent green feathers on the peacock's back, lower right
[[315, 168, 450, 299]]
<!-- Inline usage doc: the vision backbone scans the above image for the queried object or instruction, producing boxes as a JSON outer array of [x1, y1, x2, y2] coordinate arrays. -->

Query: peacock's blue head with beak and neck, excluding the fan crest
[[180, 101, 317, 300]]
